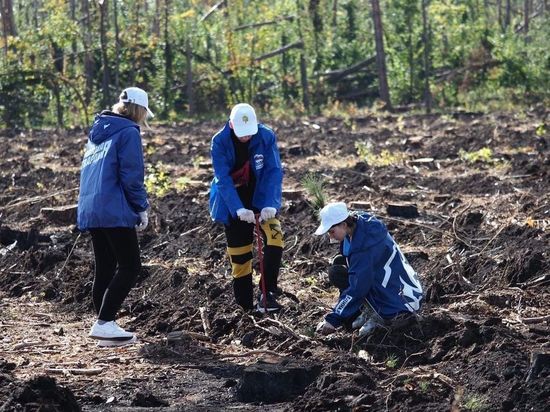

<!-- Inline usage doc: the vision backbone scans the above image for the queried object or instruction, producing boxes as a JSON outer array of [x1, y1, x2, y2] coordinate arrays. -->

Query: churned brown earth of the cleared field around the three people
[[0, 108, 550, 411]]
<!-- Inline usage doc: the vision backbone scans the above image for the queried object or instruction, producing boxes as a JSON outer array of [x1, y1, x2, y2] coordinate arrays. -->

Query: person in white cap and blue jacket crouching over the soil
[[315, 202, 422, 336]]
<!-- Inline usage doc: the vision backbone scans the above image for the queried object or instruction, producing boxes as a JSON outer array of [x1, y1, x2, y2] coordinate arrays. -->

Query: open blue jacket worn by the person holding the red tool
[[210, 122, 283, 224]]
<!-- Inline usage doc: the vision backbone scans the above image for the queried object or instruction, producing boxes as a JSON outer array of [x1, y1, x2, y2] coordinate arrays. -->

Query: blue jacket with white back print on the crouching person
[[325, 213, 422, 327]]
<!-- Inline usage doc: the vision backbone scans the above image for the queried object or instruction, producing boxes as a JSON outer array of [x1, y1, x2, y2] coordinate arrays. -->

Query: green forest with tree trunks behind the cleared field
[[0, 0, 550, 128]]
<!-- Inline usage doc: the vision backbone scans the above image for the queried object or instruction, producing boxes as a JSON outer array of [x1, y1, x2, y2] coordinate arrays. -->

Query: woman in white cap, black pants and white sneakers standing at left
[[78, 87, 153, 346]]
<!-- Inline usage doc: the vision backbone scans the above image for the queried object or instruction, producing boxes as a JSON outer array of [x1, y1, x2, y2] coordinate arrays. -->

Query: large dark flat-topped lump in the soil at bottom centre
[[237, 364, 321, 403]]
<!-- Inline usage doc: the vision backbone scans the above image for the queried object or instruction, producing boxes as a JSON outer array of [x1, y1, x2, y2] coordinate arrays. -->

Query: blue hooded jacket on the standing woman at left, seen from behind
[[78, 112, 149, 230]]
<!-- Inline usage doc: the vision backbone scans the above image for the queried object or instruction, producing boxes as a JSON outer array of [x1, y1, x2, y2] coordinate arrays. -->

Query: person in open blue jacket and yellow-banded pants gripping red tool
[[210, 103, 284, 311]]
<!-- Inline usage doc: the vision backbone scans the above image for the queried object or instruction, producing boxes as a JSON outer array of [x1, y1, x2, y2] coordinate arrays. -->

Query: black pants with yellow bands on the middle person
[[225, 218, 284, 309]]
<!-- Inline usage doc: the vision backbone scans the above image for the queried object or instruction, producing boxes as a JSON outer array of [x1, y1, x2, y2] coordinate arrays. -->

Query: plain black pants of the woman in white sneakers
[[90, 227, 141, 321]]
